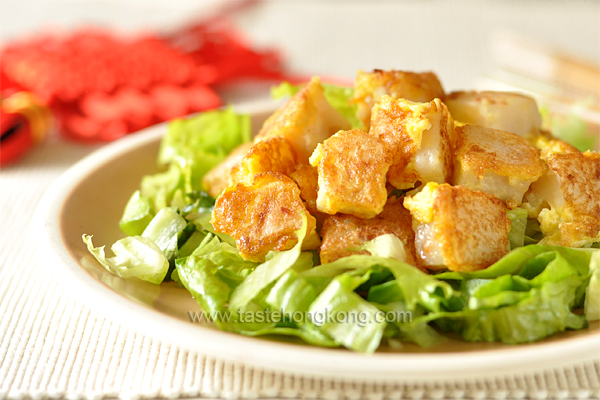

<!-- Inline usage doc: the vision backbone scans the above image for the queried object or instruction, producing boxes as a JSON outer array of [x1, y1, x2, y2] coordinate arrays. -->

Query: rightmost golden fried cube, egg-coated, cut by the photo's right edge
[[524, 152, 600, 247]]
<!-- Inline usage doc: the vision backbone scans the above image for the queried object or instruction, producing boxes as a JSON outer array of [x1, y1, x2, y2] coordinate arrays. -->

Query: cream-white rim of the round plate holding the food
[[32, 101, 600, 382]]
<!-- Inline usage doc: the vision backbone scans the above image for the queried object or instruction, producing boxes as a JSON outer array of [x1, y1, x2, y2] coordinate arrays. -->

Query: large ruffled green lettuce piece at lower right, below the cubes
[[418, 245, 598, 343]]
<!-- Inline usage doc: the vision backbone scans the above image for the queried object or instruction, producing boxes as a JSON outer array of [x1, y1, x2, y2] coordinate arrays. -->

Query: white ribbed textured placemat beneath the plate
[[0, 141, 600, 399]]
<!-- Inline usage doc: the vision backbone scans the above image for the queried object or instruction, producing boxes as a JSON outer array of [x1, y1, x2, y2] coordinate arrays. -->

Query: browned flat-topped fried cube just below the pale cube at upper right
[[452, 125, 546, 209]]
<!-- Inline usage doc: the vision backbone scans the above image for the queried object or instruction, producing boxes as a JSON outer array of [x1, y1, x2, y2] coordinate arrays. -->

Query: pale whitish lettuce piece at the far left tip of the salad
[[82, 235, 169, 285]]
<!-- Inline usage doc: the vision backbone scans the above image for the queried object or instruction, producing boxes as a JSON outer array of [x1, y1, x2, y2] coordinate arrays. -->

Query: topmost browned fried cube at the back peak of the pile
[[352, 69, 444, 129]]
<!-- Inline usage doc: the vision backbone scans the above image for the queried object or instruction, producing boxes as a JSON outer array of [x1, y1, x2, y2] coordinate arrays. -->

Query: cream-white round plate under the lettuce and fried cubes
[[34, 99, 600, 382]]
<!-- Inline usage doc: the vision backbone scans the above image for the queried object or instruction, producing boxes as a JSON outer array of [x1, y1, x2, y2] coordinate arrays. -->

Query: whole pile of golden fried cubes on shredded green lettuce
[[83, 70, 600, 353]]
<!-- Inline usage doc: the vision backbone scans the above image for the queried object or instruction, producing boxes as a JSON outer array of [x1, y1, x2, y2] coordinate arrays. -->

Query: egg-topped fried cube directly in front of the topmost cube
[[370, 96, 454, 189]]
